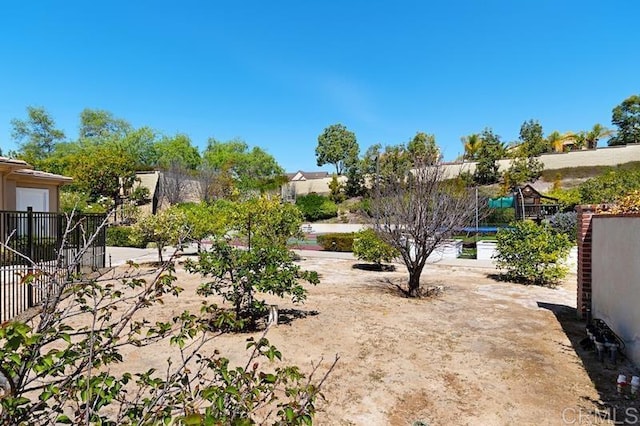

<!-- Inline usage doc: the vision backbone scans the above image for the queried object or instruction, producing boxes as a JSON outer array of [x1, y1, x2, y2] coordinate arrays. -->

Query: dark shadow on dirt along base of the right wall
[[538, 302, 640, 425]]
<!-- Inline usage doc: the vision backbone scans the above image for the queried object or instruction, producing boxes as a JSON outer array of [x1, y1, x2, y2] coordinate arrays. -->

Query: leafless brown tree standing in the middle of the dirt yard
[[373, 156, 476, 297]]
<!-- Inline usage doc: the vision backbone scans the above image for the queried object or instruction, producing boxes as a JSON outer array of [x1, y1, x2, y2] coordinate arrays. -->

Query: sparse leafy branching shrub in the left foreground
[[0, 218, 337, 425]]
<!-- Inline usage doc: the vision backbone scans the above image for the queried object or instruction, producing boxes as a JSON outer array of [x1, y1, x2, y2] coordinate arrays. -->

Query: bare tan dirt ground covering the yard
[[110, 257, 629, 426]]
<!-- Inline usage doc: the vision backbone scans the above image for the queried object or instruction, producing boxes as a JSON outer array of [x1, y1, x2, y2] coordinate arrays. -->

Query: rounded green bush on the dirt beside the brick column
[[494, 220, 571, 285]]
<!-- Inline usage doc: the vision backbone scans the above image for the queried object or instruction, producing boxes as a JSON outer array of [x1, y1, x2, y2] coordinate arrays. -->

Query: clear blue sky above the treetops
[[0, 0, 640, 171]]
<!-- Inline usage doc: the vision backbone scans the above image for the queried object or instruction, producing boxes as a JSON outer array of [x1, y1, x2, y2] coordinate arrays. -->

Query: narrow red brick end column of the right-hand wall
[[576, 205, 597, 318]]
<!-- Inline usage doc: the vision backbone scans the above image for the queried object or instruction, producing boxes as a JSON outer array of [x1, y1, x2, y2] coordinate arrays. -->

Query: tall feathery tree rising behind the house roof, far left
[[11, 106, 65, 166]]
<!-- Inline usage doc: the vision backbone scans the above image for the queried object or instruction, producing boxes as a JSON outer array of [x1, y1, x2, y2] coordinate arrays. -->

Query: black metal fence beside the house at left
[[0, 210, 106, 321]]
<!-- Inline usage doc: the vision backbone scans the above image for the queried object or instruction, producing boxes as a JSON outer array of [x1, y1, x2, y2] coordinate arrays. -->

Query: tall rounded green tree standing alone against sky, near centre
[[316, 124, 360, 176]]
